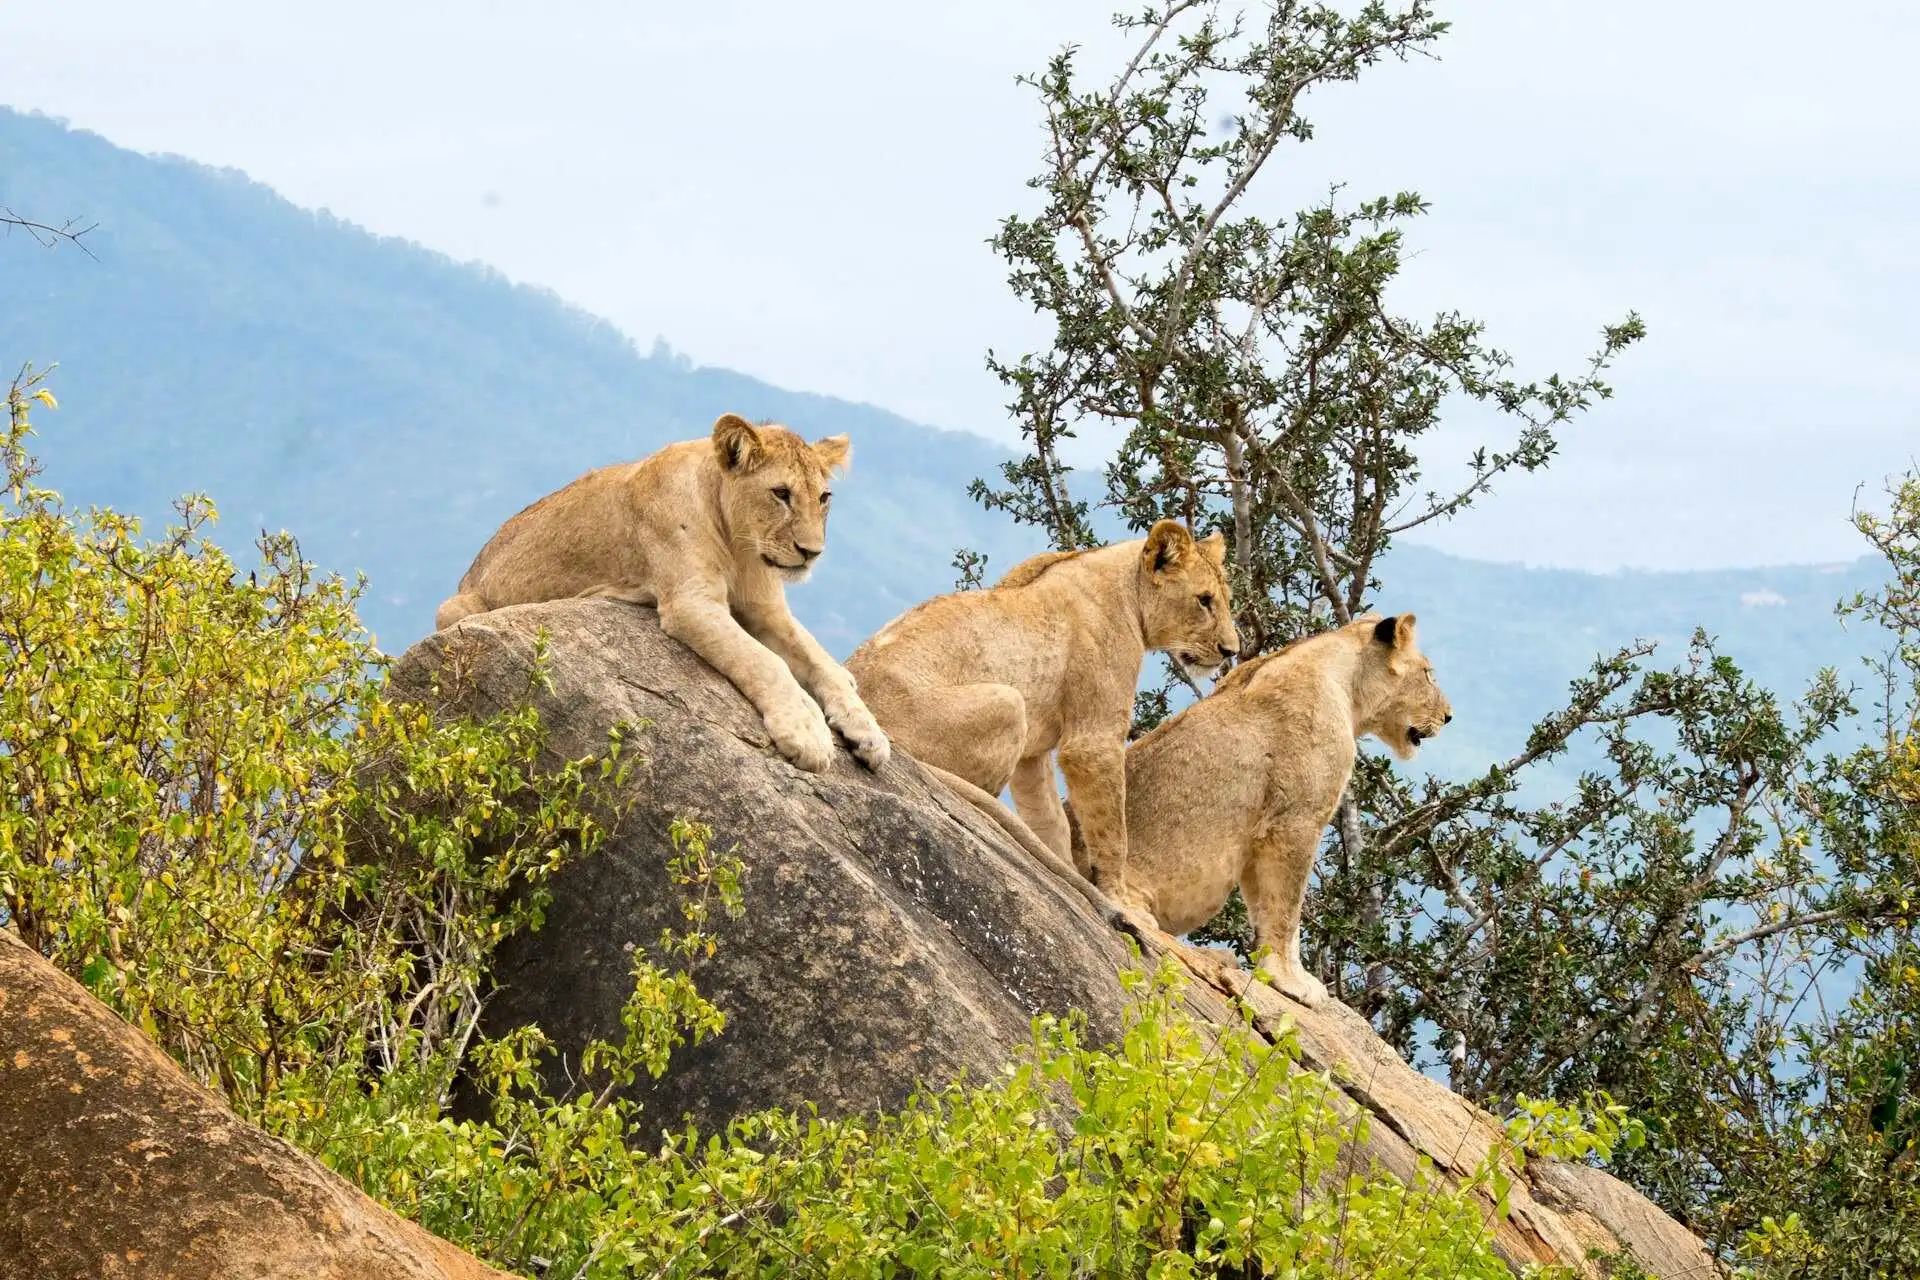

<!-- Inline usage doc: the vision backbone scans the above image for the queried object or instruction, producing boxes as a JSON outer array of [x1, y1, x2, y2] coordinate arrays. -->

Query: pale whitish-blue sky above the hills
[[0, 0, 1920, 570]]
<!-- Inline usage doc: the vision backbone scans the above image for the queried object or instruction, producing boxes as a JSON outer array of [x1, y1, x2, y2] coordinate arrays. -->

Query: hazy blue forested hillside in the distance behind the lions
[[0, 111, 1872, 790]]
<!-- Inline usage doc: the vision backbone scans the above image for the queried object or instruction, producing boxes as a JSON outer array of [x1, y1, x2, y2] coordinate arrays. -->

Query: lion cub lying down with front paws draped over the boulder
[[434, 413, 887, 773]]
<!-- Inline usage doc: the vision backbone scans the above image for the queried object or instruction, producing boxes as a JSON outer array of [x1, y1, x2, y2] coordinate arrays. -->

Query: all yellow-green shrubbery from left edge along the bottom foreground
[[0, 364, 1615, 1280]]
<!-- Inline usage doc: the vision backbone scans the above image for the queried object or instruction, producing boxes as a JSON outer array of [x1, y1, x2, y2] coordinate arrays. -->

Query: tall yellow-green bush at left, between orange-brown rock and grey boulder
[[0, 362, 616, 1115]]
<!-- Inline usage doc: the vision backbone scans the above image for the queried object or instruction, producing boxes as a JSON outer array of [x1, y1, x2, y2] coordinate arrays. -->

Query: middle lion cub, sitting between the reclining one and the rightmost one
[[847, 520, 1240, 908]]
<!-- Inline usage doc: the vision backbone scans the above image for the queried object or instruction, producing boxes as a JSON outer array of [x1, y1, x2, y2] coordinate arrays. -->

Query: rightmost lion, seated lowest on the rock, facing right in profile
[[1105, 614, 1453, 1007]]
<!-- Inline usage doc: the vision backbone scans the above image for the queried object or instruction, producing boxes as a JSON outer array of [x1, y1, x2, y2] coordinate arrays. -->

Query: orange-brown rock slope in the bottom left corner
[[0, 933, 505, 1280]]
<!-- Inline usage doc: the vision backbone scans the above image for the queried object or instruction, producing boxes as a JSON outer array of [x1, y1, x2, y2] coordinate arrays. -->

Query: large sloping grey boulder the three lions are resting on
[[394, 601, 1716, 1278]]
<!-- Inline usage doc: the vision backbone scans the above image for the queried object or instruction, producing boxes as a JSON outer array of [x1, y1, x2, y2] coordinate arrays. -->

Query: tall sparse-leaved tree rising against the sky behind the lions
[[973, 0, 1642, 1013]]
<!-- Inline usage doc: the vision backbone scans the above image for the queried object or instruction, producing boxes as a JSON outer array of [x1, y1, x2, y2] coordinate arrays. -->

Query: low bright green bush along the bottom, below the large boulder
[[295, 961, 1611, 1280]]
